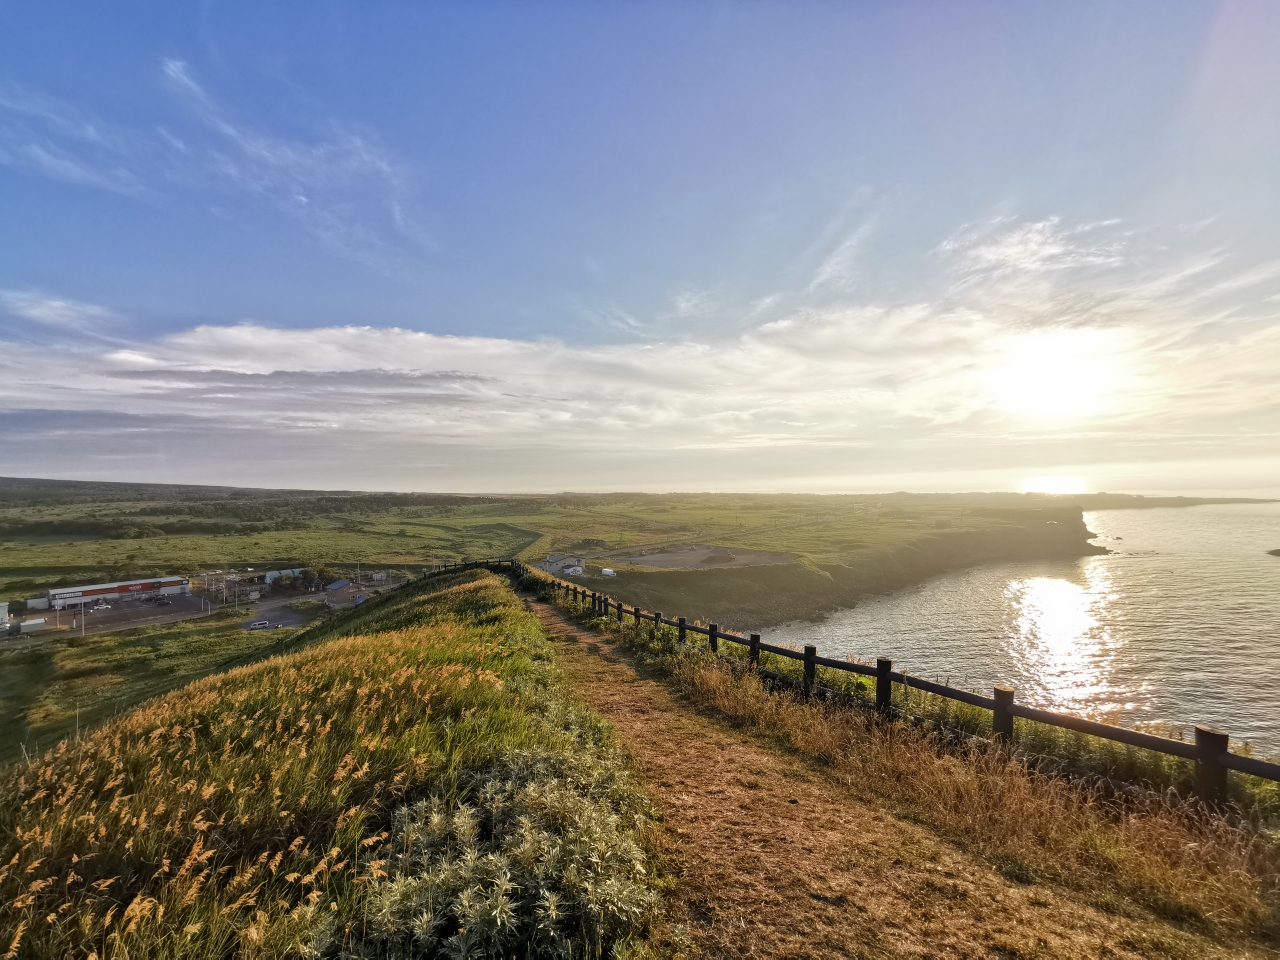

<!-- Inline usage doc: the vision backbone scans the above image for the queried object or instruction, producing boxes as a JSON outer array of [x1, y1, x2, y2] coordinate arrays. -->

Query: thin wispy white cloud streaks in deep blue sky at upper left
[[0, 59, 428, 268]]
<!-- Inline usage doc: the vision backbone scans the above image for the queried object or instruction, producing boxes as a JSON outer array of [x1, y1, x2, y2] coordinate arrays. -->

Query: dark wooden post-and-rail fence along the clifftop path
[[435, 559, 1280, 804]]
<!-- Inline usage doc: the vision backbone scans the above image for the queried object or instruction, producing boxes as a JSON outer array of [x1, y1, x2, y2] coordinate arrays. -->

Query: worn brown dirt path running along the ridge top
[[529, 600, 1270, 959]]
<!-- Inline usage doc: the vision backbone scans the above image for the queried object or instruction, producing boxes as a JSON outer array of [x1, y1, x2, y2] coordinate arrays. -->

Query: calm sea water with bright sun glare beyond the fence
[[764, 504, 1280, 755]]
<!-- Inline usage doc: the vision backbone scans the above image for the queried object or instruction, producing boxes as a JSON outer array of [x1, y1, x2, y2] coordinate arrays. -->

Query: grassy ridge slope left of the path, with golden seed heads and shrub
[[0, 572, 655, 957]]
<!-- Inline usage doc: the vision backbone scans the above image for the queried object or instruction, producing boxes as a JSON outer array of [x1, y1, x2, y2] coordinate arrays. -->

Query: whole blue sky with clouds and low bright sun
[[0, 0, 1280, 495]]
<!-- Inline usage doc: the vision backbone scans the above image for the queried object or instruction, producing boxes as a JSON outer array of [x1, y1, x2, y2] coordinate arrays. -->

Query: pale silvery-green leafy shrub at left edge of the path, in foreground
[[343, 751, 657, 957]]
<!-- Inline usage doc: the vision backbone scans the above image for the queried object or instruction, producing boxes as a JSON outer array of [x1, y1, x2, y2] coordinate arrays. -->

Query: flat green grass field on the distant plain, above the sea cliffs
[[0, 479, 1187, 616]]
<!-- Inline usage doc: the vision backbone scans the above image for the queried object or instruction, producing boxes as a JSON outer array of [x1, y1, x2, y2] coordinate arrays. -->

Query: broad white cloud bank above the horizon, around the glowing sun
[[0, 215, 1280, 489]]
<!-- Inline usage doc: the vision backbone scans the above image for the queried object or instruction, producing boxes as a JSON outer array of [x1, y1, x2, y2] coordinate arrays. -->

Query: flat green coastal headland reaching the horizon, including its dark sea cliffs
[[0, 477, 1269, 627]]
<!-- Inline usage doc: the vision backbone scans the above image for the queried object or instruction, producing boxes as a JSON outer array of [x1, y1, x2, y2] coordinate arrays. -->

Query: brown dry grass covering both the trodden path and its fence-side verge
[[522, 599, 1277, 957]]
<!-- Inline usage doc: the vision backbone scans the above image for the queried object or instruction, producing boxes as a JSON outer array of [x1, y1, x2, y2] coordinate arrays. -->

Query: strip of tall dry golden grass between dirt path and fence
[[526, 576, 1280, 943]]
